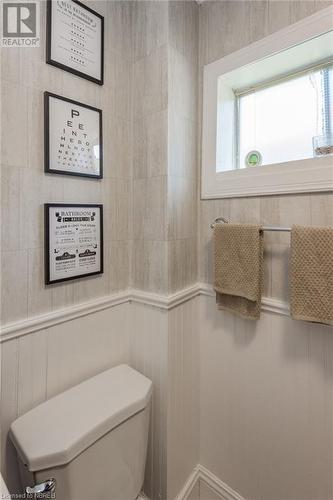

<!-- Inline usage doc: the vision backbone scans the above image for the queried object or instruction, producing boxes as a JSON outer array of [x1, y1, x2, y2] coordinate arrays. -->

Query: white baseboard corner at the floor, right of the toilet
[[175, 464, 245, 500]]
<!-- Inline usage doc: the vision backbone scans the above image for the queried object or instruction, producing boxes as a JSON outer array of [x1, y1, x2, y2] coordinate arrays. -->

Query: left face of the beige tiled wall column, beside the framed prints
[[132, 1, 168, 293]]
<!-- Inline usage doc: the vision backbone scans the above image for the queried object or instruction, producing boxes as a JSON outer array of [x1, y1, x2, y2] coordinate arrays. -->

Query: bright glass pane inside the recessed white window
[[236, 65, 333, 168]]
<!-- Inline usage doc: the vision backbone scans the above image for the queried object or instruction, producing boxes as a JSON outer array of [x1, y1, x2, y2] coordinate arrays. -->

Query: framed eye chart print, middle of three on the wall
[[44, 92, 103, 179]]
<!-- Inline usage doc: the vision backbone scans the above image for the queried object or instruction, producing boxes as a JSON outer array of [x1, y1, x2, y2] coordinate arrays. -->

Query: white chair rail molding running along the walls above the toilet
[[0, 282, 289, 343]]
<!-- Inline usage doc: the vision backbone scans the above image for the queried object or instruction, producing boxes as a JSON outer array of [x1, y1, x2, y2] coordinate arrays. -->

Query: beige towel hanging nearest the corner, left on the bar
[[214, 224, 263, 319]]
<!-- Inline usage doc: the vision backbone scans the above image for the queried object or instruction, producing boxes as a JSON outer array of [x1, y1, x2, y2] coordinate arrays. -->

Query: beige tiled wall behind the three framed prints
[[1, 1, 132, 324]]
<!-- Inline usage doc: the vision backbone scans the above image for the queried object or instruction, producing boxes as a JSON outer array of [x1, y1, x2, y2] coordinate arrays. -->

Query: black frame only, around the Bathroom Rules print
[[44, 203, 104, 285]]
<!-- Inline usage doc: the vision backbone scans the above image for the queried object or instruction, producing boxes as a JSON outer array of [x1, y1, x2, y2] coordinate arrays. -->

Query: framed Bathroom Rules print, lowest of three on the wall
[[44, 203, 103, 285]]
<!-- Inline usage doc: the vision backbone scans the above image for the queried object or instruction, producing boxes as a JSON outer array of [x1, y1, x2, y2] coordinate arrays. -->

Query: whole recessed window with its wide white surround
[[201, 7, 333, 198]]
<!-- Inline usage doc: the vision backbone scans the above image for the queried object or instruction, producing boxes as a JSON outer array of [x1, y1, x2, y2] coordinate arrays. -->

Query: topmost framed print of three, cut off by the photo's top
[[46, 0, 104, 85]]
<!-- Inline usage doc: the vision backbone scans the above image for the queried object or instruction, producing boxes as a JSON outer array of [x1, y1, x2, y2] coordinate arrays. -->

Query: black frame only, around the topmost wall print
[[46, 0, 104, 85]]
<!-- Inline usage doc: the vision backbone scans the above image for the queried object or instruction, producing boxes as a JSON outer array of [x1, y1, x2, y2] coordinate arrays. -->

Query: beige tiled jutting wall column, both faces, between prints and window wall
[[132, 1, 198, 293]]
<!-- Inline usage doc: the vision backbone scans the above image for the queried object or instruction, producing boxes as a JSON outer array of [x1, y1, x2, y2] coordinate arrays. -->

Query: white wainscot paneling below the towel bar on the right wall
[[199, 297, 333, 500]]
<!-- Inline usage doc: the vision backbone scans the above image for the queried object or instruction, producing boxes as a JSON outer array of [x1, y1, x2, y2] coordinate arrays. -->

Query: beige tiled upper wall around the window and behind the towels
[[198, 0, 333, 301]]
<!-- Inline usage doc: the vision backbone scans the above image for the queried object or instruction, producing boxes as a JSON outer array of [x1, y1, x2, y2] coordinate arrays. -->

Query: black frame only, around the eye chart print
[[44, 92, 103, 179]]
